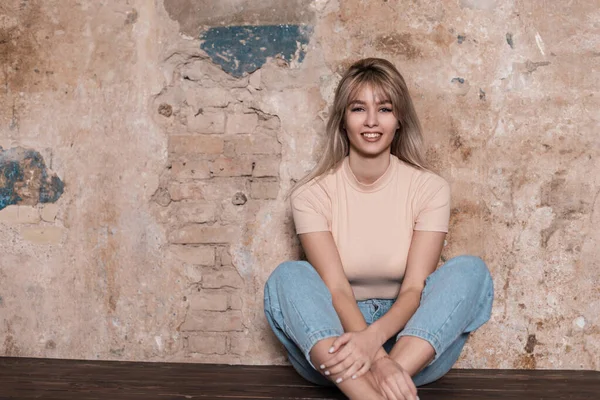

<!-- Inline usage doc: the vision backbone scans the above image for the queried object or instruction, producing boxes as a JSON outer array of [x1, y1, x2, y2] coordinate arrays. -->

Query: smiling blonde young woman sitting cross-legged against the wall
[[265, 58, 494, 400]]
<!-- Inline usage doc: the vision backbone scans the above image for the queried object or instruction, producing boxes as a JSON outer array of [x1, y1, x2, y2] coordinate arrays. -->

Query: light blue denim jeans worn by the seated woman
[[265, 256, 494, 386]]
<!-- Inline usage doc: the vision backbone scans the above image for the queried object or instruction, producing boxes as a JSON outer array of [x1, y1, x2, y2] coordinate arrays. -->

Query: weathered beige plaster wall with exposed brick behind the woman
[[0, 0, 600, 370]]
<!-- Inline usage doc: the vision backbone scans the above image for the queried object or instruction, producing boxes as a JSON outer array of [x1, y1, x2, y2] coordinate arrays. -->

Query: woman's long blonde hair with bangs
[[286, 58, 427, 198]]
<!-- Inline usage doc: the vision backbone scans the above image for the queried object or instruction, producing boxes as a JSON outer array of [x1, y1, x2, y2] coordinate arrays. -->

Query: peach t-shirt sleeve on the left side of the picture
[[291, 182, 331, 234]]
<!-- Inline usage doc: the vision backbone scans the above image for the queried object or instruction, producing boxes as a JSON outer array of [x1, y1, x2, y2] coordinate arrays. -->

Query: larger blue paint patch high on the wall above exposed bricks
[[200, 25, 312, 77]]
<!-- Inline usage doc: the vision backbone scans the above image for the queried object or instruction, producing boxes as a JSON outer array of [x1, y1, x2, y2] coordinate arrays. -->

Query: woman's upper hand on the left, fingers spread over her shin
[[320, 329, 381, 383]]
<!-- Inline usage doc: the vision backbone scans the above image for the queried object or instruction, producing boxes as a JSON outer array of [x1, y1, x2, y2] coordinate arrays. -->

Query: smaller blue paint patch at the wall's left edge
[[0, 147, 65, 210]]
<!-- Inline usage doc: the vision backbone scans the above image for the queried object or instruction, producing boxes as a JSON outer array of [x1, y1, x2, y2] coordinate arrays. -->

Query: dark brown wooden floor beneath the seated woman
[[0, 357, 600, 400]]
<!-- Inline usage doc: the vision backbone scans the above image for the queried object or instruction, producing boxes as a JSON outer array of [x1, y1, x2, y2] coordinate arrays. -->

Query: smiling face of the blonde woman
[[344, 85, 400, 158]]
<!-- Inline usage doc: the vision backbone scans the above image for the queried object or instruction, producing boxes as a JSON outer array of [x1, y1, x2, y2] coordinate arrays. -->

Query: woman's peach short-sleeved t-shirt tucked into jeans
[[291, 155, 450, 300]]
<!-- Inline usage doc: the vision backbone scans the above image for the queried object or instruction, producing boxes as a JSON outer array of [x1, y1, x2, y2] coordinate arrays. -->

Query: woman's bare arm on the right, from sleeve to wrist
[[368, 231, 446, 345]]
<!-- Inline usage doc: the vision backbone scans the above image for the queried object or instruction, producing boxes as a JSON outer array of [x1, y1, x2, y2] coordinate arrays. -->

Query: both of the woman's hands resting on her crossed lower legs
[[320, 328, 417, 400]]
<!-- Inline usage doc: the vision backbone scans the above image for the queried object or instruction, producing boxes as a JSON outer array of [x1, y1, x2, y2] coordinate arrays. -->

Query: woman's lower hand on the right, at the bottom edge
[[371, 356, 418, 400]]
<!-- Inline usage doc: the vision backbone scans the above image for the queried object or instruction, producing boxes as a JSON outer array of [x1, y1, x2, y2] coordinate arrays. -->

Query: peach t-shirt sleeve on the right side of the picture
[[414, 174, 450, 232]]
